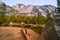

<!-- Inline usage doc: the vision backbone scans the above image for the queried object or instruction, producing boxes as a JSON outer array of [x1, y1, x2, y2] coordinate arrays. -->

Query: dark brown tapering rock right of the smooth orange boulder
[[44, 19, 59, 40]]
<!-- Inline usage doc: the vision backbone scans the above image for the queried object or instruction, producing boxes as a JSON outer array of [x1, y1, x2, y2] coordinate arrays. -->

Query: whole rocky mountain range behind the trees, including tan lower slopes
[[0, 2, 55, 17]]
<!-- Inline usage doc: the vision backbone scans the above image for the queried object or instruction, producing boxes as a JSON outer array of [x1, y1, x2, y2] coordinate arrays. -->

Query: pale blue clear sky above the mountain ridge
[[2, 0, 57, 6]]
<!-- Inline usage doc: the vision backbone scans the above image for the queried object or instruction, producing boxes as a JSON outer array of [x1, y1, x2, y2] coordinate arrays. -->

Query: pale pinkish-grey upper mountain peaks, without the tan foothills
[[13, 4, 55, 17]]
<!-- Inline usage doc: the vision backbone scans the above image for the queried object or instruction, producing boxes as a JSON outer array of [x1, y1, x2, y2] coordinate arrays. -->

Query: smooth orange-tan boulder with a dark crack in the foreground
[[0, 27, 43, 40]]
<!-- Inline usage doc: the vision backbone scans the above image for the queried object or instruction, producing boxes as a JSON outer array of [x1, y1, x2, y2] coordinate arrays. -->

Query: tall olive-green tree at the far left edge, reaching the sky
[[0, 2, 6, 23]]
